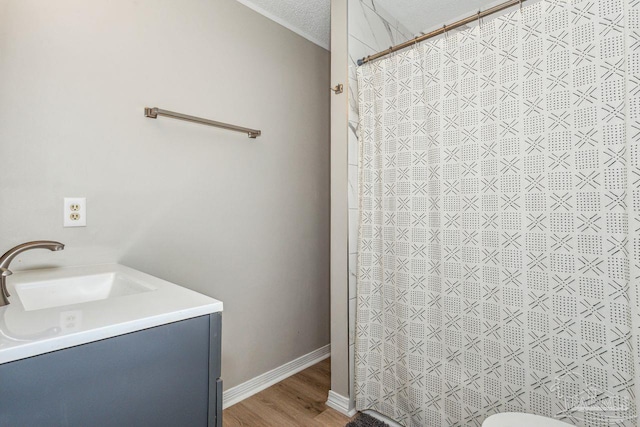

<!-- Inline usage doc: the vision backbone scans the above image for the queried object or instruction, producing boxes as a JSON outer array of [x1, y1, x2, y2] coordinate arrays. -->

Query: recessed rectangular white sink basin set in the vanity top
[[15, 272, 156, 311]]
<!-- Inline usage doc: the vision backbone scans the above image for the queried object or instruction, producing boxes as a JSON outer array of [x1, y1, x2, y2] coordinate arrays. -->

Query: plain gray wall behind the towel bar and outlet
[[0, 0, 330, 388]]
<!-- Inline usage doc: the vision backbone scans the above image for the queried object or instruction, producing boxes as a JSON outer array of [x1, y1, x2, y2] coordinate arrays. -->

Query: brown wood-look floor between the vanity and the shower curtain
[[222, 359, 350, 427]]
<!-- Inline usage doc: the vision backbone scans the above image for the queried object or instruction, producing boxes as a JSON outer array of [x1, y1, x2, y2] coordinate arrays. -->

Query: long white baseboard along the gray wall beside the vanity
[[222, 344, 331, 409]]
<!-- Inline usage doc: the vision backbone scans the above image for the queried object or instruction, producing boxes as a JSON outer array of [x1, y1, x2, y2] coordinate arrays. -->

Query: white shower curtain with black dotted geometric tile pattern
[[355, 0, 640, 427]]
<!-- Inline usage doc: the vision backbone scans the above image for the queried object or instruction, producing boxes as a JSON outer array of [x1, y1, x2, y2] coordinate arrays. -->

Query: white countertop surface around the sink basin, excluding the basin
[[0, 264, 222, 364]]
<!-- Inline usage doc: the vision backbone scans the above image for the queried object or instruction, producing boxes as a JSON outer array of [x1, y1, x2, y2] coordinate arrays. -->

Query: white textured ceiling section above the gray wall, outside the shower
[[238, 0, 331, 50]]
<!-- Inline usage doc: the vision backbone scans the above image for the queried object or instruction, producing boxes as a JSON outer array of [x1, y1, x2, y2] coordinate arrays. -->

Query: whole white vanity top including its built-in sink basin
[[0, 264, 222, 366]]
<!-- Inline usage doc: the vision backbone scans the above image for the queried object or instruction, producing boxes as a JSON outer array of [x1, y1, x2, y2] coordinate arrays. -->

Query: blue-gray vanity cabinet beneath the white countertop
[[0, 313, 222, 427]]
